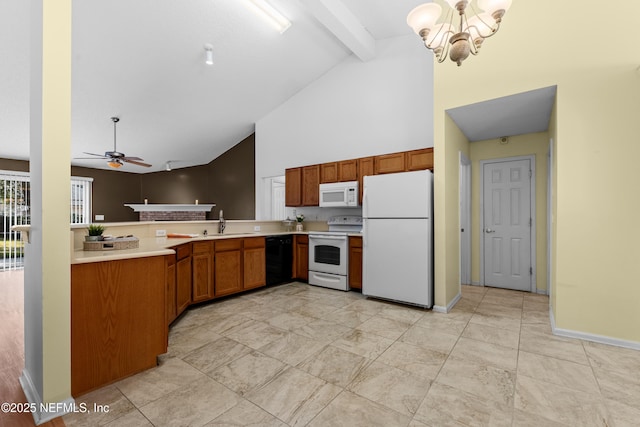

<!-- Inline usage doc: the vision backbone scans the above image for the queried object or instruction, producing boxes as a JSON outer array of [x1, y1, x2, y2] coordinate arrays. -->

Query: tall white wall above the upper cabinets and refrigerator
[[256, 35, 433, 219]]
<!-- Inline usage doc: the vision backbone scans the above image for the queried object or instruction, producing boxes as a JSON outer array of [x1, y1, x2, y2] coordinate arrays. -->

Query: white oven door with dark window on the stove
[[309, 234, 348, 276]]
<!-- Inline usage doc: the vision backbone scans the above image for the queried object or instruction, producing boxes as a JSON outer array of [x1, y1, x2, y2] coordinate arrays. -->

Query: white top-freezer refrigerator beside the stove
[[362, 170, 433, 308]]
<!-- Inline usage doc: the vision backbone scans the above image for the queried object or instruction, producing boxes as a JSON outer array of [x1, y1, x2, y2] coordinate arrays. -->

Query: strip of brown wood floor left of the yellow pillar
[[0, 270, 65, 427]]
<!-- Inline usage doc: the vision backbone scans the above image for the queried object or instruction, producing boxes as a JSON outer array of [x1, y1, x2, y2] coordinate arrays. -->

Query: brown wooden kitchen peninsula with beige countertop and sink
[[71, 221, 326, 397]]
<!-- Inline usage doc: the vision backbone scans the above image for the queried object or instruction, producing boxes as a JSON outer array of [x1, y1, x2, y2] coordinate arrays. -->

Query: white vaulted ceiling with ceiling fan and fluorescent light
[[0, 0, 427, 172]]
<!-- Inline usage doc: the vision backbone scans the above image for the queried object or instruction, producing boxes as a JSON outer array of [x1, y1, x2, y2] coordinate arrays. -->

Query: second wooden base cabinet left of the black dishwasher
[[215, 239, 243, 297]]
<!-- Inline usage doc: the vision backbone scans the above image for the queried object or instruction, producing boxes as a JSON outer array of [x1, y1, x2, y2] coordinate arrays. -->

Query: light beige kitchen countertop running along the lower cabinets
[[71, 230, 361, 264]]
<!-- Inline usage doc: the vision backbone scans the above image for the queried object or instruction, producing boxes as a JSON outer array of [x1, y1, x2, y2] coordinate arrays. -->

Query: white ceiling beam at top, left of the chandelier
[[300, 0, 376, 61]]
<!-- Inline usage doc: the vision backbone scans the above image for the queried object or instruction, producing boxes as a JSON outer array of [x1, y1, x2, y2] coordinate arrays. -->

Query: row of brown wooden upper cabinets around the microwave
[[285, 148, 433, 207]]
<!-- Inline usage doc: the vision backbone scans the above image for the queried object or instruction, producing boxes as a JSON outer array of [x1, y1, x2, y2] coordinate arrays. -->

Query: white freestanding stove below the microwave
[[309, 215, 362, 291]]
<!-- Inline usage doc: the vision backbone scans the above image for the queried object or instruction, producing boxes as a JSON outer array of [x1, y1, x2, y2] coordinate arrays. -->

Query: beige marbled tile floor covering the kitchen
[[64, 283, 640, 427]]
